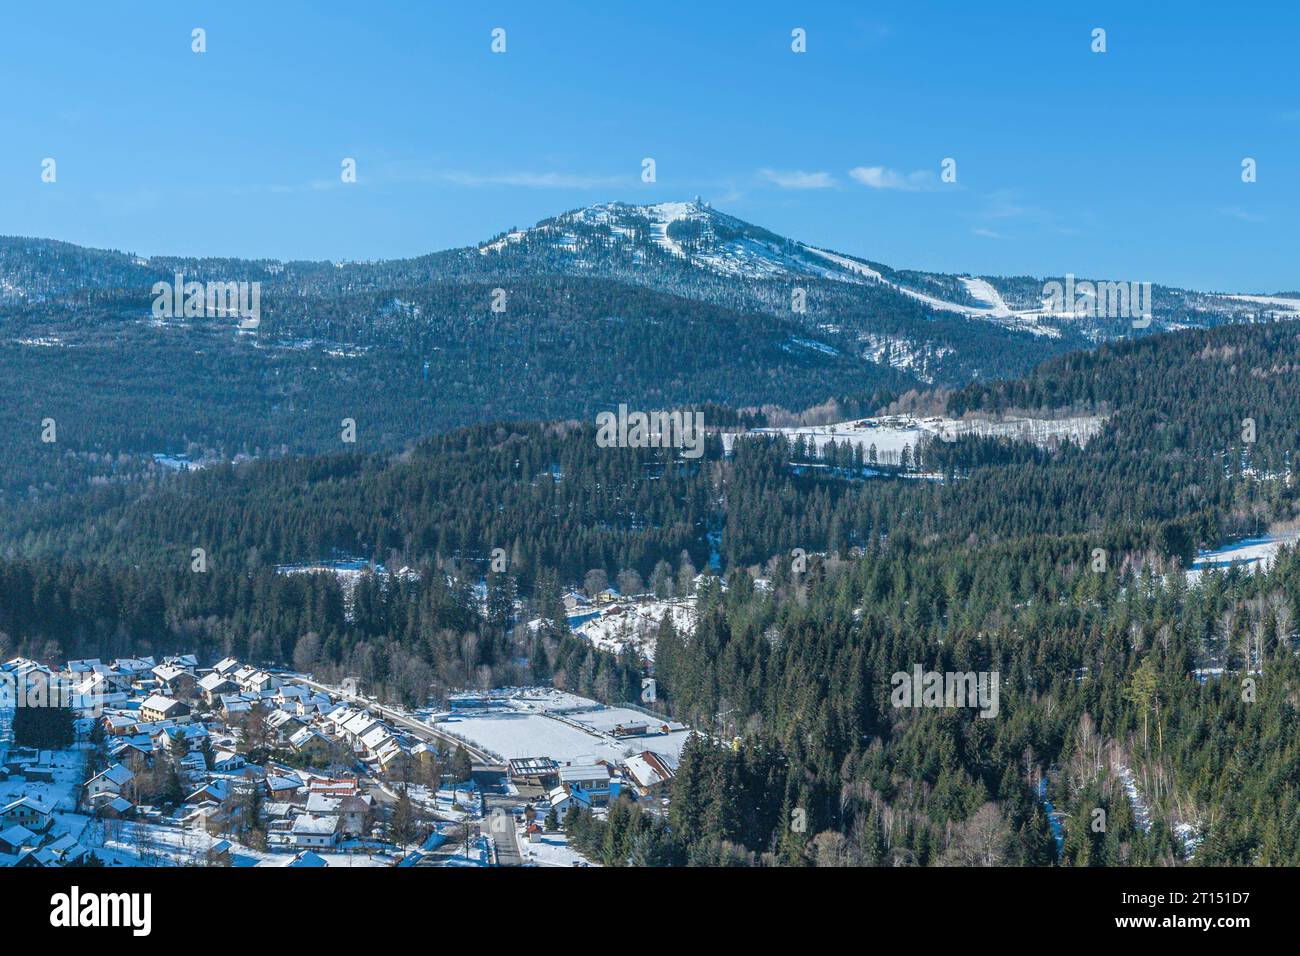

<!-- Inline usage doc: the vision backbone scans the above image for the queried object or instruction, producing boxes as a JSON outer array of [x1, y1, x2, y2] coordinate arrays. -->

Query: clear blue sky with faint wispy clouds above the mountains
[[0, 0, 1300, 291]]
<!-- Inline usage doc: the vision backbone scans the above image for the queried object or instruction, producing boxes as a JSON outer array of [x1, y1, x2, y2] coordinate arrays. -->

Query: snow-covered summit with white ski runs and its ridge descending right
[[477, 198, 1300, 341]]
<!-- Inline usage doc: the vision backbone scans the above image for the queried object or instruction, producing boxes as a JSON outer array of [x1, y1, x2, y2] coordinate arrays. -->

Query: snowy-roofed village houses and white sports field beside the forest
[[0, 634, 692, 868]]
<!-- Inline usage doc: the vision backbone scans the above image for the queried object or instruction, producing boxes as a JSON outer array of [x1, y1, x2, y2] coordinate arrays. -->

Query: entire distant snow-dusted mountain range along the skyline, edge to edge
[[0, 199, 1300, 385]]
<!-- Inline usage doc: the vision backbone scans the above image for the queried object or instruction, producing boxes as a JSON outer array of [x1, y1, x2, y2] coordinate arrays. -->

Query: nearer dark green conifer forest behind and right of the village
[[0, 323, 1300, 865]]
